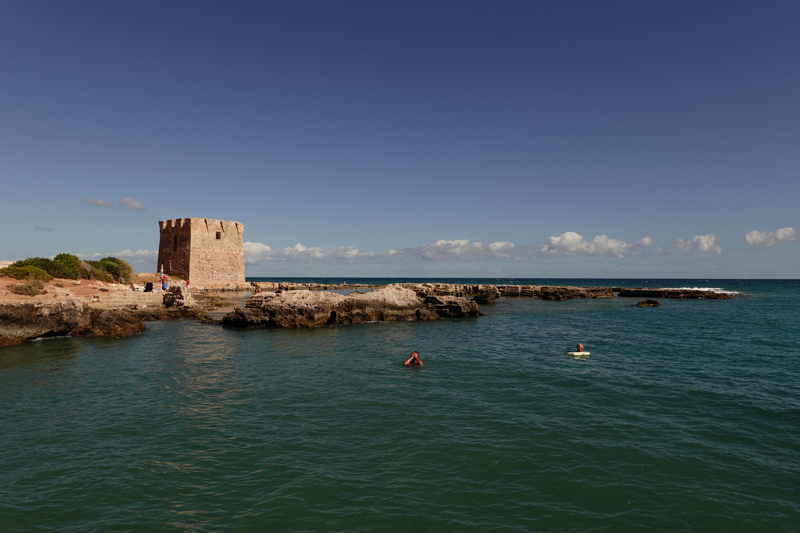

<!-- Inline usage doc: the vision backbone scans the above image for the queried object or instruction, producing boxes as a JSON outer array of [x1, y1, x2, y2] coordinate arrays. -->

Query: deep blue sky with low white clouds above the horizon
[[0, 0, 800, 278]]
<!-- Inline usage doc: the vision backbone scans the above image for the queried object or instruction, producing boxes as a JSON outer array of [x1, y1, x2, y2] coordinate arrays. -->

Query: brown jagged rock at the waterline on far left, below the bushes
[[0, 299, 87, 346]]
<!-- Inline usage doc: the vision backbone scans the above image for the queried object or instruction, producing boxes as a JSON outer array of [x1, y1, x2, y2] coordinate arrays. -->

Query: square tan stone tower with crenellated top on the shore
[[157, 218, 245, 287]]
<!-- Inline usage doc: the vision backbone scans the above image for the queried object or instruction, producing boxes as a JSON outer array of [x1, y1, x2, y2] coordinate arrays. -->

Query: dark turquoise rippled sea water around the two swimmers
[[0, 279, 800, 532]]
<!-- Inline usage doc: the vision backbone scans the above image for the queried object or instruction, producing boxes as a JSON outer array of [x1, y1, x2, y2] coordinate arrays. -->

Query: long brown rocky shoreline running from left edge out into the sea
[[0, 276, 732, 346]]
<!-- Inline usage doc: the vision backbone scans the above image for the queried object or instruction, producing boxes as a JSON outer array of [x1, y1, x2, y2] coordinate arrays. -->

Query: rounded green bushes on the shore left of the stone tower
[[0, 254, 133, 284]]
